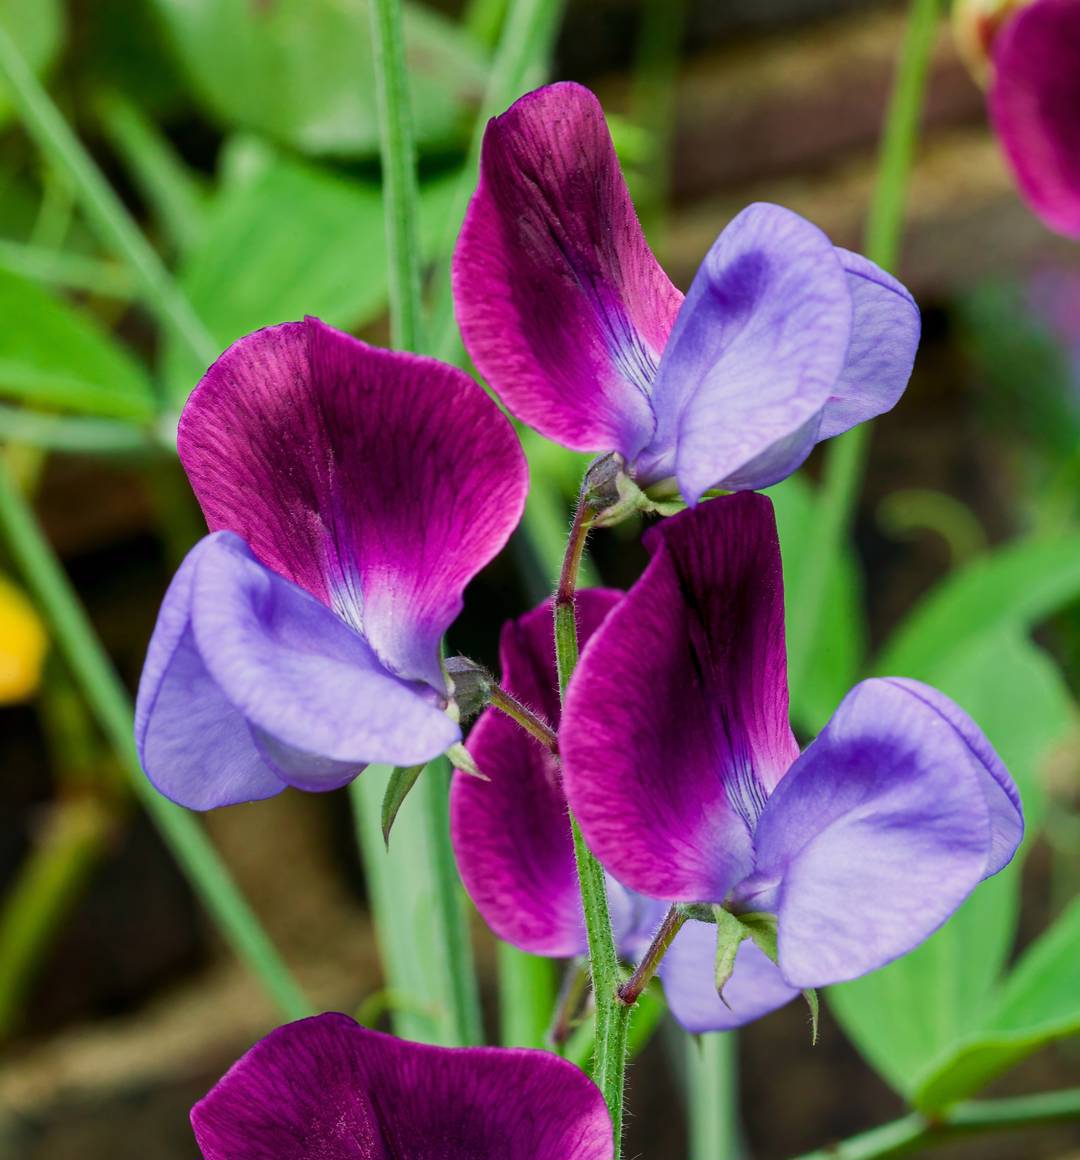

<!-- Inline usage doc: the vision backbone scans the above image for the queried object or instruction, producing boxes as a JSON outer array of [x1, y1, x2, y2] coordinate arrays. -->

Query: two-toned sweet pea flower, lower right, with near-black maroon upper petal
[[559, 494, 1023, 1030]]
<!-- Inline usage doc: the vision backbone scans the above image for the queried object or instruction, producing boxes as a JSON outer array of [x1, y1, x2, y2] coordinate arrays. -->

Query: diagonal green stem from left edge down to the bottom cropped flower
[[0, 456, 311, 1018]]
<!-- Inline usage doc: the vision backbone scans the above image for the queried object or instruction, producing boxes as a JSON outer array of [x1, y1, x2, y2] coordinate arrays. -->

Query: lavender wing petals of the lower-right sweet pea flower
[[751, 680, 994, 987]]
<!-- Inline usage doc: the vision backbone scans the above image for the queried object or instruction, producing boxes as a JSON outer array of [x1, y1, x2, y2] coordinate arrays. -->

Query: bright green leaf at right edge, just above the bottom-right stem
[[915, 899, 1080, 1111]]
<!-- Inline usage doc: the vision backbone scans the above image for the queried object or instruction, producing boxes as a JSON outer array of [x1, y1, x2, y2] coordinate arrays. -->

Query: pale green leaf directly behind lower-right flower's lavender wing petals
[[828, 628, 1075, 1096]]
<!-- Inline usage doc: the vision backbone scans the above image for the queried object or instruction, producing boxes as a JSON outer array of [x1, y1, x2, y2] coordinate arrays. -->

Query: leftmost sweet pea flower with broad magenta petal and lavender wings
[[136, 318, 528, 810]]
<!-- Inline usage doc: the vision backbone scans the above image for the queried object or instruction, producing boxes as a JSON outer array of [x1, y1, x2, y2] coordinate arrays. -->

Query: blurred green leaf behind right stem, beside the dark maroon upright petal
[[768, 476, 867, 733]]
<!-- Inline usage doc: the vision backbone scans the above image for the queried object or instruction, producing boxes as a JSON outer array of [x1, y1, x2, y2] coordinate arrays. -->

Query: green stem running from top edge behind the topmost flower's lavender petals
[[788, 0, 941, 689]]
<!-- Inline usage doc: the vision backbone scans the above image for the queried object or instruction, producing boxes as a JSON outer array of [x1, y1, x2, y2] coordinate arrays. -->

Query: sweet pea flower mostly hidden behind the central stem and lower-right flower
[[450, 588, 797, 1031]]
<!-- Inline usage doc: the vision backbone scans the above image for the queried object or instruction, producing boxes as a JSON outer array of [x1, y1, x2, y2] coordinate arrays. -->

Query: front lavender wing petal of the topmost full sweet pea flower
[[637, 204, 853, 503]]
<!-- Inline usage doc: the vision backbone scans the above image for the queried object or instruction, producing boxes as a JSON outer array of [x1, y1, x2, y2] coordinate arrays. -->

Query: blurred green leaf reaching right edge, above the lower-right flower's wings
[[874, 532, 1080, 680]]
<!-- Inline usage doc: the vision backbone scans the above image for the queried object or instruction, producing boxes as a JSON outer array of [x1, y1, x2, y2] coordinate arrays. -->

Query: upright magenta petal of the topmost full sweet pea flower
[[454, 84, 682, 459]]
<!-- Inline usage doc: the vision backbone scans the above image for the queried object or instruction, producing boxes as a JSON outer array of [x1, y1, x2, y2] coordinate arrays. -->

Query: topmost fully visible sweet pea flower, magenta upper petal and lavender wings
[[452, 77, 919, 503]]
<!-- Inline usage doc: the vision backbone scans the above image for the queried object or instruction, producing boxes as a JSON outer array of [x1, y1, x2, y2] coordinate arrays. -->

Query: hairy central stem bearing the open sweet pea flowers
[[555, 487, 633, 1146]]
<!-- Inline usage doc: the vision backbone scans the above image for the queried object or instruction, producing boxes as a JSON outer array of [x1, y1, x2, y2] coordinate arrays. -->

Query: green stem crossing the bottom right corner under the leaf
[[799, 1088, 1080, 1160]]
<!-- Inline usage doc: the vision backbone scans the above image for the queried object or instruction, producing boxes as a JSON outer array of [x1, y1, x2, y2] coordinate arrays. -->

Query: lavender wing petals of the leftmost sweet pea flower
[[137, 532, 461, 810]]
